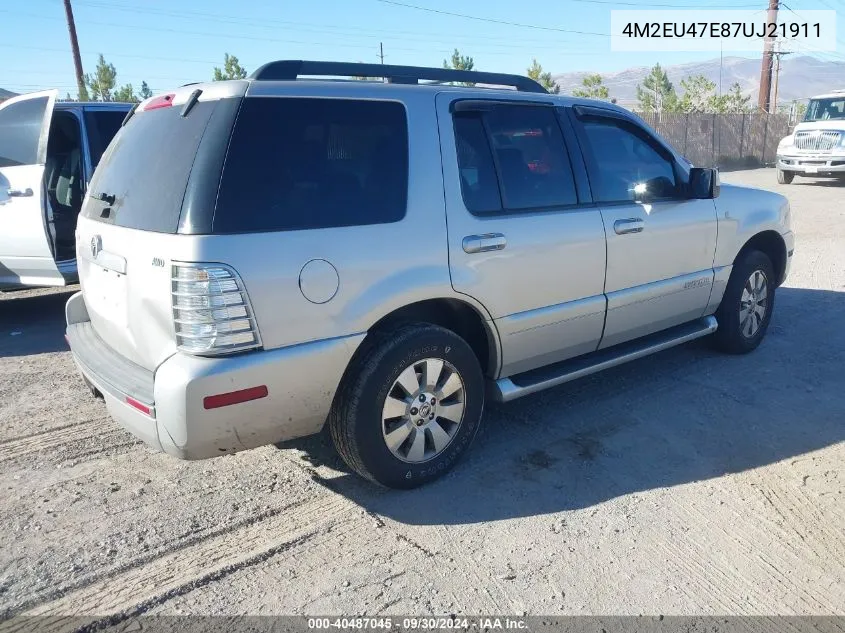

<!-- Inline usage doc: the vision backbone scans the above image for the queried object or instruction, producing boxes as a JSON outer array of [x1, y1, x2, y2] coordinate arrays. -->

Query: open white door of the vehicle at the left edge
[[0, 90, 65, 286]]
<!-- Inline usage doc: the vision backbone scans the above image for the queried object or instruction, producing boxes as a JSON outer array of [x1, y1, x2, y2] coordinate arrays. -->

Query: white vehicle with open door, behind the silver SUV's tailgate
[[0, 90, 132, 290]]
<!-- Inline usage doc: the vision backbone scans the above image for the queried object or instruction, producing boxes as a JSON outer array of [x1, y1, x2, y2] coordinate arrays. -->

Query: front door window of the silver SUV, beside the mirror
[[582, 117, 680, 202]]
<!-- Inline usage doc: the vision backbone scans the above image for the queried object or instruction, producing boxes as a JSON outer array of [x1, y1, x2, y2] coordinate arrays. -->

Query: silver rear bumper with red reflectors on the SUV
[[66, 293, 363, 459]]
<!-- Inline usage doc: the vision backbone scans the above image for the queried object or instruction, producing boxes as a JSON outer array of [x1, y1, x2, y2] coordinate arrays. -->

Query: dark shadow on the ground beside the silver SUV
[[288, 288, 845, 524]]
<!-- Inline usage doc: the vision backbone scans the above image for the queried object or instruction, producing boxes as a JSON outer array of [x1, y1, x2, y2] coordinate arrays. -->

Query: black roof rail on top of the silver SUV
[[249, 59, 548, 92]]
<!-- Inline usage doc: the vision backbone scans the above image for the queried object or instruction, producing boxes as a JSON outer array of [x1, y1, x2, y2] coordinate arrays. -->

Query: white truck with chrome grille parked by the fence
[[777, 90, 845, 185]]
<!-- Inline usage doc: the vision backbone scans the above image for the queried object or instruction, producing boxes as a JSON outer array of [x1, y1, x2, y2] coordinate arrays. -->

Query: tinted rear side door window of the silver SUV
[[454, 105, 578, 214]]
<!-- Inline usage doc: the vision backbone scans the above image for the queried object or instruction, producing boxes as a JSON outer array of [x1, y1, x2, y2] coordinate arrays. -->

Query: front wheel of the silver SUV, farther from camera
[[713, 251, 777, 354]]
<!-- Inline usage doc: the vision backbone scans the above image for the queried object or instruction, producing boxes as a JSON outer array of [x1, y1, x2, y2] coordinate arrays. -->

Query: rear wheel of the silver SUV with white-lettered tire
[[328, 323, 485, 489]]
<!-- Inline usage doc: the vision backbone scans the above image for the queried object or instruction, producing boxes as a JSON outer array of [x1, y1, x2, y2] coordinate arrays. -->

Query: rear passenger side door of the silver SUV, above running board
[[437, 92, 606, 376]]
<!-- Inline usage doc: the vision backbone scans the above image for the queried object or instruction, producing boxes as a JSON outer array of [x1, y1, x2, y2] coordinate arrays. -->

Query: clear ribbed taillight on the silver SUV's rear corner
[[171, 264, 261, 355]]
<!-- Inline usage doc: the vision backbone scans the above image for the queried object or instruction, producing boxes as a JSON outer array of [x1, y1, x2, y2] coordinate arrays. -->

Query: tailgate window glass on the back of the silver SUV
[[82, 101, 219, 233]]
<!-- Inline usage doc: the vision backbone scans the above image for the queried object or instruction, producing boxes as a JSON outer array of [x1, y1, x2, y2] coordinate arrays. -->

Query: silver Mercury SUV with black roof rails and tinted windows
[[67, 61, 793, 488]]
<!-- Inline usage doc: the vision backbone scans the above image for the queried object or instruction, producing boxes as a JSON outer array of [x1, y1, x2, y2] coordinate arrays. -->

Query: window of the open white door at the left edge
[[0, 96, 49, 167]]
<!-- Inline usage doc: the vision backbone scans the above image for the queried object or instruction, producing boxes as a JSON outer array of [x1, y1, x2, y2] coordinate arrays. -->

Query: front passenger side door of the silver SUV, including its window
[[572, 108, 717, 348]]
